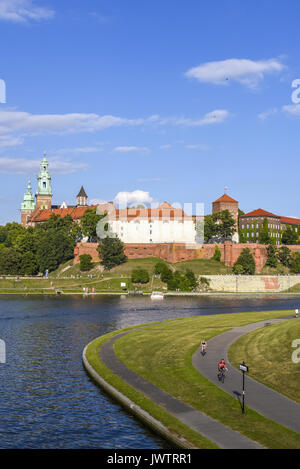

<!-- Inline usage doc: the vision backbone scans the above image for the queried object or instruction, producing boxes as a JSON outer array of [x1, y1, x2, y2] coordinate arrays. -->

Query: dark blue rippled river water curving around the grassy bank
[[0, 295, 300, 449]]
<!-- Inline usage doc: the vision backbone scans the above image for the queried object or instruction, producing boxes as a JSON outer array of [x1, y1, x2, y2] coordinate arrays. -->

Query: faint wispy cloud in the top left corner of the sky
[[0, 0, 55, 23]]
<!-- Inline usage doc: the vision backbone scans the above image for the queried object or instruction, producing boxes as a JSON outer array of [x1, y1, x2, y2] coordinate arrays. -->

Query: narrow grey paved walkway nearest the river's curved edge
[[99, 331, 262, 449]]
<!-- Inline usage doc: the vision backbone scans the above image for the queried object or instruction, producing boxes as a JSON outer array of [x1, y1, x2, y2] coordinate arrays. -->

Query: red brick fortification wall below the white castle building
[[74, 242, 300, 272]]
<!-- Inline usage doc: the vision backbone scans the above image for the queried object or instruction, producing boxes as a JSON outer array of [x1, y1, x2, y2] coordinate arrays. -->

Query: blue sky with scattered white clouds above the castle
[[0, 0, 300, 224]]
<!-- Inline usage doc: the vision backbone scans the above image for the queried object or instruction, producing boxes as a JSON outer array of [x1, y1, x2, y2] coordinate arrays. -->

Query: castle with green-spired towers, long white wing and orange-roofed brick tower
[[21, 154, 238, 245]]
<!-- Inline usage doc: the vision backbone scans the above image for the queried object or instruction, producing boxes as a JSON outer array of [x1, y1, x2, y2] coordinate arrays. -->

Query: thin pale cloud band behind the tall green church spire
[[0, 158, 87, 174]]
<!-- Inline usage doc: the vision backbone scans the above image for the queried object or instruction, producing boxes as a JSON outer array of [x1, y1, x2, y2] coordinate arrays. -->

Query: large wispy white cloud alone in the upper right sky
[[185, 59, 285, 88]]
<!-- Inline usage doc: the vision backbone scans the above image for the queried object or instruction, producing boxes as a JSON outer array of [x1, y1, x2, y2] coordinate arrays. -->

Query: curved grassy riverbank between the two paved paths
[[84, 311, 300, 449]]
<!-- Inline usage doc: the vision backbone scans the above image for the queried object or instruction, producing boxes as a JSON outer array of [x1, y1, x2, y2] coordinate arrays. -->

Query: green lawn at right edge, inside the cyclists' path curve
[[229, 319, 300, 403]]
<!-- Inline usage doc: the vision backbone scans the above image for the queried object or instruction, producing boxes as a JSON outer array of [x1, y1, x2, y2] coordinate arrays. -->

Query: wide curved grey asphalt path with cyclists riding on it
[[193, 318, 300, 433]]
